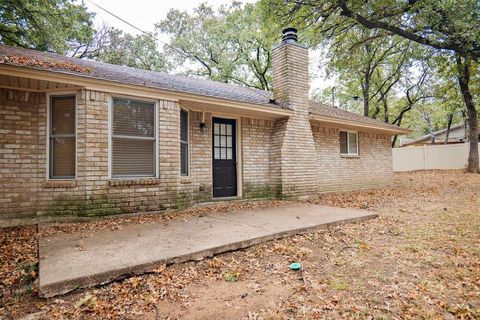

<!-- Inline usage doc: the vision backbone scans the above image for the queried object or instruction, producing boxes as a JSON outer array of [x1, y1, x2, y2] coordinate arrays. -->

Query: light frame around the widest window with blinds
[[108, 95, 160, 180]]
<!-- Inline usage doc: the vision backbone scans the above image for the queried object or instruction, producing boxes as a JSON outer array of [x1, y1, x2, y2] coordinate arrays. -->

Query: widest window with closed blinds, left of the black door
[[111, 98, 157, 178]]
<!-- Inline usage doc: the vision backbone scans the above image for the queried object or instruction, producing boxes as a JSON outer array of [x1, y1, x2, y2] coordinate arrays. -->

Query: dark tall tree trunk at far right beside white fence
[[456, 54, 480, 173]]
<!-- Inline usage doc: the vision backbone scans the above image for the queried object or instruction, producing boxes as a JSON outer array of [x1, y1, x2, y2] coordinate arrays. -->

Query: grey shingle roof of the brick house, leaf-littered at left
[[0, 45, 408, 130]]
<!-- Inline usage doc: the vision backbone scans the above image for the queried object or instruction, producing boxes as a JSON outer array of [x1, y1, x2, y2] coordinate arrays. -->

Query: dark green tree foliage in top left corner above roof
[[0, 0, 94, 54]]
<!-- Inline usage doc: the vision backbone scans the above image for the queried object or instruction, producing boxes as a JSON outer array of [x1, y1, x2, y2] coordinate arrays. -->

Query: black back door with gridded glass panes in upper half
[[212, 118, 237, 198]]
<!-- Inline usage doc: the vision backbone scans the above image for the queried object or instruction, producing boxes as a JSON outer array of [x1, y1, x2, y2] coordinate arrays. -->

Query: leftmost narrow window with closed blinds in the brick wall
[[48, 95, 76, 179]]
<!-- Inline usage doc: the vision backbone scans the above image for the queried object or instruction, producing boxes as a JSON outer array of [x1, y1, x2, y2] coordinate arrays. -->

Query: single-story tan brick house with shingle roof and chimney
[[0, 29, 408, 221]]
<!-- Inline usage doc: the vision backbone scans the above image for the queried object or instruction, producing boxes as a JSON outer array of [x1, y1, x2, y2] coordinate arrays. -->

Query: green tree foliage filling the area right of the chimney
[[262, 0, 480, 146]]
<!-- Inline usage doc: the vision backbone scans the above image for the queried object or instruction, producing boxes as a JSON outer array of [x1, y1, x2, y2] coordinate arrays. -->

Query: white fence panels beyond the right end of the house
[[392, 143, 480, 171]]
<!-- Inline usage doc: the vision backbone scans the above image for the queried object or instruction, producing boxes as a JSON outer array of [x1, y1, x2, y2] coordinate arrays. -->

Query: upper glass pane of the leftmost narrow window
[[51, 96, 75, 134]]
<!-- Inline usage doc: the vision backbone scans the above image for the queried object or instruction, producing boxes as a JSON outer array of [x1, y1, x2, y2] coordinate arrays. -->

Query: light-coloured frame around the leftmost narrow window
[[45, 91, 78, 181]]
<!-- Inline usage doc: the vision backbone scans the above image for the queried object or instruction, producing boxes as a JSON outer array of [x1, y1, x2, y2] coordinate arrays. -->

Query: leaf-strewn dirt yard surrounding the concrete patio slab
[[0, 171, 480, 319]]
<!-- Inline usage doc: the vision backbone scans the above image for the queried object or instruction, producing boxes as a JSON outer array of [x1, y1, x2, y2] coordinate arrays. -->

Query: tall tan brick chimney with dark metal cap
[[270, 28, 318, 198]]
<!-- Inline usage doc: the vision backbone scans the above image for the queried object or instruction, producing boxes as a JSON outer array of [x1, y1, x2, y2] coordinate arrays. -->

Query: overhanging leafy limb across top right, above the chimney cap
[[263, 0, 480, 60]]
